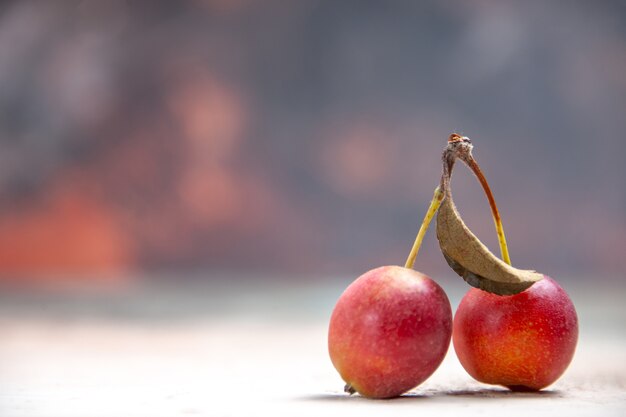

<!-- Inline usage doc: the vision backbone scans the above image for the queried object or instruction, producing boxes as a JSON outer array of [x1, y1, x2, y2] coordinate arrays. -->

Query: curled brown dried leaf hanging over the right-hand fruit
[[437, 192, 543, 295]]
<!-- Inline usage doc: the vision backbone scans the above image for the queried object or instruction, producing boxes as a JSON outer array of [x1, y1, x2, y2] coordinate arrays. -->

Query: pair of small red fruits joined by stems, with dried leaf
[[328, 134, 578, 398]]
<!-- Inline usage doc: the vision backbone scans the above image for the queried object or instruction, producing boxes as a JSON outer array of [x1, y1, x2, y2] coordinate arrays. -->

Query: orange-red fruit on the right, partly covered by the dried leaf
[[453, 276, 578, 391]]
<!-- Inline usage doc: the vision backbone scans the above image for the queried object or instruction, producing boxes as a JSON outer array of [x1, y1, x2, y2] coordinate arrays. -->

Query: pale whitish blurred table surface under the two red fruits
[[0, 274, 626, 417]]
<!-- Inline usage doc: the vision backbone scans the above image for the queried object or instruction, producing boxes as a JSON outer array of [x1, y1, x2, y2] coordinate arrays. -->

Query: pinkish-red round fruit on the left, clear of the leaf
[[328, 266, 452, 398]]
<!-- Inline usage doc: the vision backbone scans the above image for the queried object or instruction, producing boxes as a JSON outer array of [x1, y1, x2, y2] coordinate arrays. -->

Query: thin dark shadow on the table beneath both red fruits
[[298, 388, 563, 403]]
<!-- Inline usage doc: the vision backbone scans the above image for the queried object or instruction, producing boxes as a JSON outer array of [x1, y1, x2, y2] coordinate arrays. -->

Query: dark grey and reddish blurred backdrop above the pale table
[[0, 0, 626, 282]]
